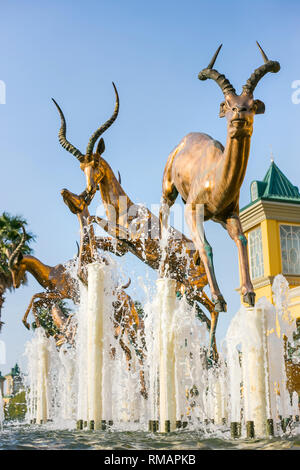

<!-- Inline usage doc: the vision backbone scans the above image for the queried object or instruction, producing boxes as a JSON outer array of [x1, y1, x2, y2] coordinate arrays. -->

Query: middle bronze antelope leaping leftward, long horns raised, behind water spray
[[53, 85, 218, 358]]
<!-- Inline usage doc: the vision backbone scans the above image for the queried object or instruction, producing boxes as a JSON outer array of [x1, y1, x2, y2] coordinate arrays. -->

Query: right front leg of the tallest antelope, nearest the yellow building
[[226, 214, 255, 307]]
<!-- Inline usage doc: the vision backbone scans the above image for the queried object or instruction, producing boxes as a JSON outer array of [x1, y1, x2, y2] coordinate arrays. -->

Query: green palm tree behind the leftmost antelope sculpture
[[0, 212, 35, 331]]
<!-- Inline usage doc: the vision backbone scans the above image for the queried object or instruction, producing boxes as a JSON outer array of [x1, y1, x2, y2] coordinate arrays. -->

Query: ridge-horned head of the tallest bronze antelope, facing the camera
[[198, 42, 280, 137]]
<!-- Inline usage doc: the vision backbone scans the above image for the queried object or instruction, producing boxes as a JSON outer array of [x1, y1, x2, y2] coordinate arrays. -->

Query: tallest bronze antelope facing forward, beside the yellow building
[[160, 43, 280, 311]]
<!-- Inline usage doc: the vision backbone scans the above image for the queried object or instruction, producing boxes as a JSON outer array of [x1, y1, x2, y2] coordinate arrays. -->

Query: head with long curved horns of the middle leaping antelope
[[52, 83, 119, 198]]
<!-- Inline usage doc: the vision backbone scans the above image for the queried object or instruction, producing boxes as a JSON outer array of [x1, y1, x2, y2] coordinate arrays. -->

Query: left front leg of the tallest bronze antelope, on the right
[[185, 204, 227, 312]]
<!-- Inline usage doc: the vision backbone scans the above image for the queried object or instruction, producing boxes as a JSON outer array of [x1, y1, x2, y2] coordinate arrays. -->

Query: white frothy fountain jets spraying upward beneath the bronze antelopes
[[1, 263, 299, 448]]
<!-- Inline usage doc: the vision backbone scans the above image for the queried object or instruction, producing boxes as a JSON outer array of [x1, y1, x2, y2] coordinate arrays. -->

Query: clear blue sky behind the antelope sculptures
[[0, 0, 300, 371]]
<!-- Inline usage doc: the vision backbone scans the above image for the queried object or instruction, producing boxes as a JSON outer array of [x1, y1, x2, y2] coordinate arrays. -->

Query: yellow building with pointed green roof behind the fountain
[[240, 161, 300, 319]]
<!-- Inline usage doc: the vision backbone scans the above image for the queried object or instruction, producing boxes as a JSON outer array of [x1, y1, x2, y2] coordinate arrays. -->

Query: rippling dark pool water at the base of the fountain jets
[[0, 425, 300, 450]]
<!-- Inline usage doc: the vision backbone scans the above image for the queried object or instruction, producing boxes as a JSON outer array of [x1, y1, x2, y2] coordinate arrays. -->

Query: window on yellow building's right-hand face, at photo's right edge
[[280, 225, 300, 274]]
